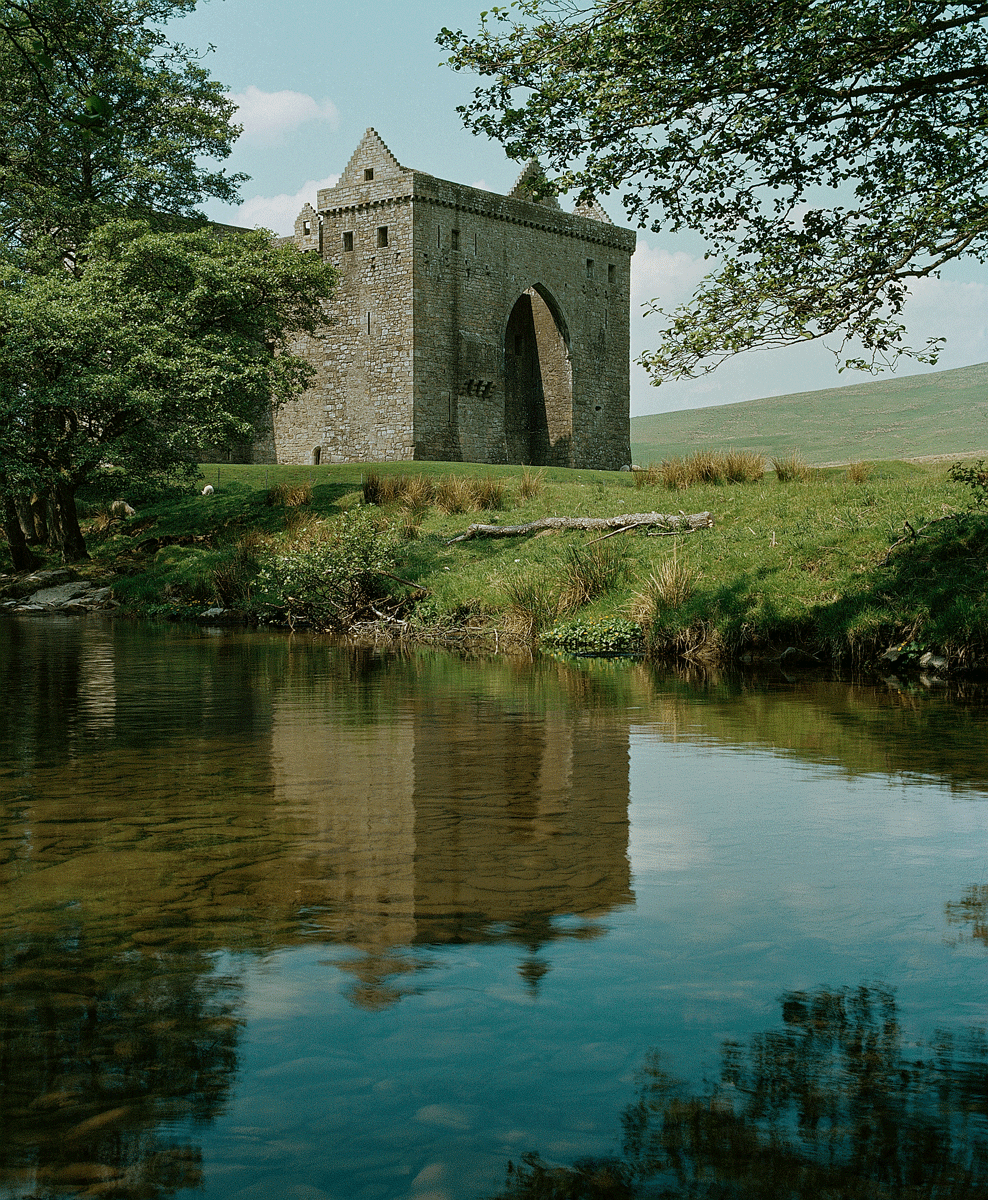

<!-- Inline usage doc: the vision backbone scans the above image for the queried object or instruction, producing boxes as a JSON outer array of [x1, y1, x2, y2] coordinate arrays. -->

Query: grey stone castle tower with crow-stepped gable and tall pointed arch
[[255, 130, 635, 469]]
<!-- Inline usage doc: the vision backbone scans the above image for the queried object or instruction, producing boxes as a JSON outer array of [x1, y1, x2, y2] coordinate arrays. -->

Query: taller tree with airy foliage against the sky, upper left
[[0, 0, 244, 270]]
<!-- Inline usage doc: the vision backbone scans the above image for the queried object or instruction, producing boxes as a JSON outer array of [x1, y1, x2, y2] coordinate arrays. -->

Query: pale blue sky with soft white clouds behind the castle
[[169, 0, 988, 416]]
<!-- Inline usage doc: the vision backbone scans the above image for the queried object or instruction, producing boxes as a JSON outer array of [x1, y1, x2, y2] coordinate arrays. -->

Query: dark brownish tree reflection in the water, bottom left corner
[[0, 929, 241, 1200]]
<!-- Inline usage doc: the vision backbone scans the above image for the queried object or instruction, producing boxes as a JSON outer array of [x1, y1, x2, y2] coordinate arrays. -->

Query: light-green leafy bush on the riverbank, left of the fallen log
[[261, 509, 399, 632]]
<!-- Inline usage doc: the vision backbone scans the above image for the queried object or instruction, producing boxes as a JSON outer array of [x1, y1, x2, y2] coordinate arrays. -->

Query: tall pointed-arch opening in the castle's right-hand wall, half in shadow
[[504, 284, 573, 467]]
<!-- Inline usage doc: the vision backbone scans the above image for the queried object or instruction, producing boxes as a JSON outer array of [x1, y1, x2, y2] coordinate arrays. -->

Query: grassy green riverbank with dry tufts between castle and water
[[7, 453, 988, 667]]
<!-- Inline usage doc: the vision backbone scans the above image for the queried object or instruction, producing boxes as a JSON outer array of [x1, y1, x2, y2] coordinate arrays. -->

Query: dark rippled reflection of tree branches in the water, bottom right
[[489, 986, 988, 1200]]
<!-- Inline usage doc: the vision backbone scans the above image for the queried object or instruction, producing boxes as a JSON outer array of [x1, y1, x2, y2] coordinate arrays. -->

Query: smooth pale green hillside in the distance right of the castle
[[631, 362, 988, 466]]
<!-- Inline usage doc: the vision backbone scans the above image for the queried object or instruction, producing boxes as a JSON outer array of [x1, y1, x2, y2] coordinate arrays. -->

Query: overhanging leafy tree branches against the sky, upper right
[[439, 0, 988, 383]]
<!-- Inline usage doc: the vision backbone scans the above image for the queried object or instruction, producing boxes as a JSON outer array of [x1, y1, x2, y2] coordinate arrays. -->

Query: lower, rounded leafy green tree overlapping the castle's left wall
[[0, 221, 336, 560]]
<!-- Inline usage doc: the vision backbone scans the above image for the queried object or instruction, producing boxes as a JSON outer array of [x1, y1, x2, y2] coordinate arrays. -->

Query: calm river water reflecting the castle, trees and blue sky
[[0, 620, 988, 1200]]
